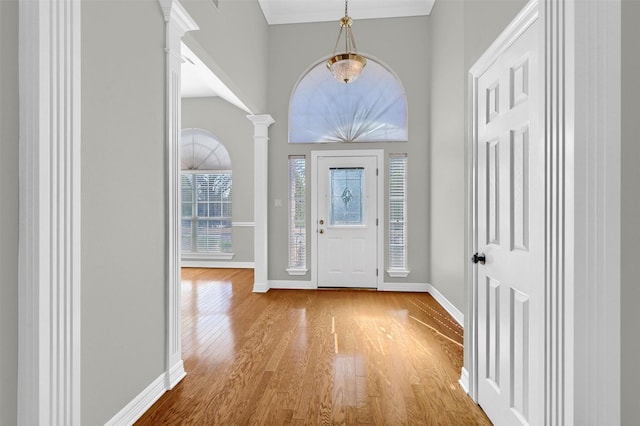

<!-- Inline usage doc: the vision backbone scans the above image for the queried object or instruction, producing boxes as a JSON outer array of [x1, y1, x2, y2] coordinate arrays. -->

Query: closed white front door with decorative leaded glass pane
[[314, 155, 378, 288]]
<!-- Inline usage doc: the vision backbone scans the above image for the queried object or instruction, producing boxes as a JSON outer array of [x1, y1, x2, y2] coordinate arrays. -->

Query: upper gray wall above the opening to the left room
[[181, 0, 268, 114]]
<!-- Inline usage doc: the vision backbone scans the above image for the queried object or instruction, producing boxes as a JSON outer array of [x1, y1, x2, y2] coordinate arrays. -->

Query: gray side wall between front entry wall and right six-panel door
[[429, 0, 526, 380]]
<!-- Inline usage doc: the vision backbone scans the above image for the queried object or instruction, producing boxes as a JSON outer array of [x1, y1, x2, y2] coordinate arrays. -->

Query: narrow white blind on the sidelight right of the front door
[[389, 154, 407, 270]]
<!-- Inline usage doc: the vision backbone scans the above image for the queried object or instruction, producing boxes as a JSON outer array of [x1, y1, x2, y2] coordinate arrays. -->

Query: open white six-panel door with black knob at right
[[472, 11, 545, 426]]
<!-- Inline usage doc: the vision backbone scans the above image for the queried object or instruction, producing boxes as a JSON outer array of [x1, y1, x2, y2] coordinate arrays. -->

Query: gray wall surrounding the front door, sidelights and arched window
[[268, 17, 430, 283]]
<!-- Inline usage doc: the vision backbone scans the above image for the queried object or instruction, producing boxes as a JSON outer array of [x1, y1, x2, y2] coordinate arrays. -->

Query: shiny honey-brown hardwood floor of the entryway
[[136, 268, 491, 426]]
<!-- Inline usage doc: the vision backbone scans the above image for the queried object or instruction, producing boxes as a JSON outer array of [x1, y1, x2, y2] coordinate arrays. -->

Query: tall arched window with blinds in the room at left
[[180, 129, 232, 256]]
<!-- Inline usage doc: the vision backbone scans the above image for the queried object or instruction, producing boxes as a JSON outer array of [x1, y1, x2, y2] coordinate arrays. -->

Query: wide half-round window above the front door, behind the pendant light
[[289, 58, 407, 143]]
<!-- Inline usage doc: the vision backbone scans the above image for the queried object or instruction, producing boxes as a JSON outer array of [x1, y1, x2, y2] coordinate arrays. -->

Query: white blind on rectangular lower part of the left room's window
[[182, 171, 232, 254]]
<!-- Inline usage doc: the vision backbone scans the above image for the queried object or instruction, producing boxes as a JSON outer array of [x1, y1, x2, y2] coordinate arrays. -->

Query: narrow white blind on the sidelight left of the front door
[[289, 155, 307, 269]]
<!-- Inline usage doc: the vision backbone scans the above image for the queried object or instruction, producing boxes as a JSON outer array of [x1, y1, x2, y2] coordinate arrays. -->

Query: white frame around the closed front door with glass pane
[[309, 149, 386, 289]]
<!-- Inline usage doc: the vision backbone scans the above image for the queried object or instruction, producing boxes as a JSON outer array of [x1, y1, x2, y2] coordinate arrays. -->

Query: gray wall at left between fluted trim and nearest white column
[[81, 0, 166, 425]]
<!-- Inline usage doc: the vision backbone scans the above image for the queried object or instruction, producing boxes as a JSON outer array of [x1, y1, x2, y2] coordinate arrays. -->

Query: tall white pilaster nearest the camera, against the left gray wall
[[159, 0, 198, 389]]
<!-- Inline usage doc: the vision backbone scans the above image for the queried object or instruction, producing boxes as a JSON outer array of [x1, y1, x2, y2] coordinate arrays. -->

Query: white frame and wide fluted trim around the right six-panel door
[[460, 0, 621, 424]]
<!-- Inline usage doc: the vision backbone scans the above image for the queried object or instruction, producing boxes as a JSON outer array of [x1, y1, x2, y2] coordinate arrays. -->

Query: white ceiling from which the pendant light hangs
[[258, 0, 435, 25]]
